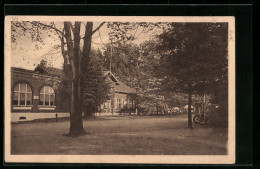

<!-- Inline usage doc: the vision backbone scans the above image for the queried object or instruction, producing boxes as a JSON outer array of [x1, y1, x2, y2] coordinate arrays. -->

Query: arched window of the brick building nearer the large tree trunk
[[40, 86, 55, 106]]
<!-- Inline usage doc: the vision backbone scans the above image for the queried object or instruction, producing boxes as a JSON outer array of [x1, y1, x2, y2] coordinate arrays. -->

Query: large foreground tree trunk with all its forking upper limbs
[[62, 22, 101, 137]]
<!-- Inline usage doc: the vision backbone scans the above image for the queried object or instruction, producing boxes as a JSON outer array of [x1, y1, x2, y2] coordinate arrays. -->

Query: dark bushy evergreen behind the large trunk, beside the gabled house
[[59, 49, 110, 115]]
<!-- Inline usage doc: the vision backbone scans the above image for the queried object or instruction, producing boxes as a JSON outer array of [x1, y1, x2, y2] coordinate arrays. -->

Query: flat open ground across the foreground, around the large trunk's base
[[11, 115, 227, 155]]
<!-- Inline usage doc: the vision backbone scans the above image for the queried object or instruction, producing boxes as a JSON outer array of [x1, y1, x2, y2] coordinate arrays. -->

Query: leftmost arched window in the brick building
[[13, 83, 32, 106]]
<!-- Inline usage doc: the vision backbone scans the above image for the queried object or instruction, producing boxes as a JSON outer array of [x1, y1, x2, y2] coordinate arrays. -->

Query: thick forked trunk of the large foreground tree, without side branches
[[69, 22, 93, 136]]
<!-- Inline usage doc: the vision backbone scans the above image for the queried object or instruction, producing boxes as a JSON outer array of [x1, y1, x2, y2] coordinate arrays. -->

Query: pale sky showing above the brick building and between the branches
[[11, 22, 158, 70]]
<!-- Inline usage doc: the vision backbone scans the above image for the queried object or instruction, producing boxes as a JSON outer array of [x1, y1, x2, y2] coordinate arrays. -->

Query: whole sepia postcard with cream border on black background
[[4, 16, 235, 164]]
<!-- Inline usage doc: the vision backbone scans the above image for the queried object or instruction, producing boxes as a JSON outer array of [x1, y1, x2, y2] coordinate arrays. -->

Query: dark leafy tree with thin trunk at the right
[[156, 23, 228, 128]]
